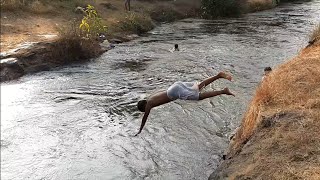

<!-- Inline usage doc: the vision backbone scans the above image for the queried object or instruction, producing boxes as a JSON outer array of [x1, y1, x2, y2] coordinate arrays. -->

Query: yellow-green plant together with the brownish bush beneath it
[[51, 5, 106, 64]]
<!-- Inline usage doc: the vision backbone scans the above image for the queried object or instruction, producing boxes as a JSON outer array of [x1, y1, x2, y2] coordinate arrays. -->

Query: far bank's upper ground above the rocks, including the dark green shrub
[[1, 0, 286, 51]]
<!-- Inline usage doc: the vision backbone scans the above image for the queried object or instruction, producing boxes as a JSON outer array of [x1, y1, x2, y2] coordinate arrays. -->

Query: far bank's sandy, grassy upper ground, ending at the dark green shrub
[[1, 0, 200, 52]]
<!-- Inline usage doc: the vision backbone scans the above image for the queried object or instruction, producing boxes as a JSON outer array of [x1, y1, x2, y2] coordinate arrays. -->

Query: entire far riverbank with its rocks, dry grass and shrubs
[[0, 0, 296, 81]]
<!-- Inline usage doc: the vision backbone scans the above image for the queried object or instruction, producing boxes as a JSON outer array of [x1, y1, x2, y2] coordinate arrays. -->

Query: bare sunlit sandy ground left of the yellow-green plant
[[0, 12, 72, 52]]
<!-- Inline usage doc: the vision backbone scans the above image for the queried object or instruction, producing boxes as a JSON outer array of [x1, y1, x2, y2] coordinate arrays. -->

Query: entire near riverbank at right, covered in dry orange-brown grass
[[209, 26, 320, 180]]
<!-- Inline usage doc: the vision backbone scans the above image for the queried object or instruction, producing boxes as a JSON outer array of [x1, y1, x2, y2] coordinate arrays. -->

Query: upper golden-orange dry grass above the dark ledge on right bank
[[230, 40, 320, 155]]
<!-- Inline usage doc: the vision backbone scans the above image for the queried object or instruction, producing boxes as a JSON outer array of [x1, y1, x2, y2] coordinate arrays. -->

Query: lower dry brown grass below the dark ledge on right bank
[[222, 112, 320, 180]]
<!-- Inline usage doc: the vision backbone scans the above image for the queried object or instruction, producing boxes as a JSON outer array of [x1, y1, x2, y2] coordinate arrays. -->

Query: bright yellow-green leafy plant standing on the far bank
[[79, 5, 107, 38]]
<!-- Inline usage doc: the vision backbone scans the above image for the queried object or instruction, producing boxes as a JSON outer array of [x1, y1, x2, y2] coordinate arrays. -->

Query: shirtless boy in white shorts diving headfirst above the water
[[135, 72, 234, 136]]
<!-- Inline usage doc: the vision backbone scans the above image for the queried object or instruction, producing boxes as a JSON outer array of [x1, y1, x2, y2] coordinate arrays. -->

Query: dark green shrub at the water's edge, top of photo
[[201, 0, 241, 19]]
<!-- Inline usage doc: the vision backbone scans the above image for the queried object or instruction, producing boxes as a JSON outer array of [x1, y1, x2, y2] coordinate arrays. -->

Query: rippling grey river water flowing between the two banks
[[1, 0, 320, 180]]
